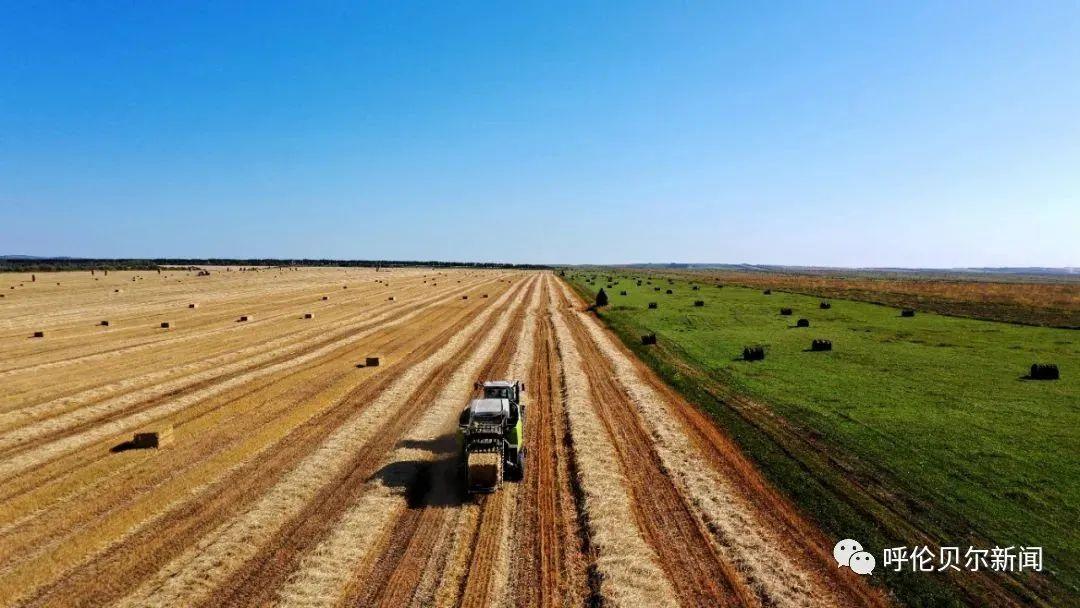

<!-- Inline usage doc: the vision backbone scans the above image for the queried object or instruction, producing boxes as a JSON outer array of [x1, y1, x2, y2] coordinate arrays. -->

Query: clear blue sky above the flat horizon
[[0, 1, 1080, 267]]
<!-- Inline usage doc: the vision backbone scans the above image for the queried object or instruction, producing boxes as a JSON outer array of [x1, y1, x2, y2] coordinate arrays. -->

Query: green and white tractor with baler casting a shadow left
[[458, 380, 525, 494]]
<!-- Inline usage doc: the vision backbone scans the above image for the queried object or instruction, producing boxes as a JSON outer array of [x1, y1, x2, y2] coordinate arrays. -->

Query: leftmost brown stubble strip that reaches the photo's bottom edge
[[6, 282, 503, 606]]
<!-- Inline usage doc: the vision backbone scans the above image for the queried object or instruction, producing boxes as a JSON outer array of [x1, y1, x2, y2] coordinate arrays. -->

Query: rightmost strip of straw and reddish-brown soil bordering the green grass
[[561, 283, 886, 606]]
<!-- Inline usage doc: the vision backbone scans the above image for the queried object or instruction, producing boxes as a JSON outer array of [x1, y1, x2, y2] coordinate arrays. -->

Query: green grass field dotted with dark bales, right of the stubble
[[570, 272, 1080, 604]]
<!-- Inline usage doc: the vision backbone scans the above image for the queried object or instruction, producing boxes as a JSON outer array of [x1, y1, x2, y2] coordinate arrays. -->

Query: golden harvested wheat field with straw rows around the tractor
[[0, 268, 888, 607]]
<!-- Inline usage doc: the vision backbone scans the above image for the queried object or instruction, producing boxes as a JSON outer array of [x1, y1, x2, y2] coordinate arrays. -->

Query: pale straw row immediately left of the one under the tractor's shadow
[[105, 276, 531, 606]]
